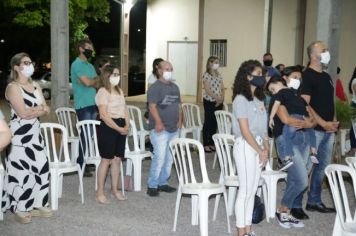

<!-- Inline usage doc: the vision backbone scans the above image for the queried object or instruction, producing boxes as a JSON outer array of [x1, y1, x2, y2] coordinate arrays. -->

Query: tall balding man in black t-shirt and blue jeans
[[301, 41, 339, 213]]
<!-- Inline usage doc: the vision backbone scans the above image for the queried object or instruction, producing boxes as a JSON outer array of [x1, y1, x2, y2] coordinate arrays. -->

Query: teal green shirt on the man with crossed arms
[[70, 57, 97, 109]]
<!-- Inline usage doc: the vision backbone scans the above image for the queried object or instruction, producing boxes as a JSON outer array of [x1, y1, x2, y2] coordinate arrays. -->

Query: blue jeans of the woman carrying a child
[[275, 131, 312, 209]]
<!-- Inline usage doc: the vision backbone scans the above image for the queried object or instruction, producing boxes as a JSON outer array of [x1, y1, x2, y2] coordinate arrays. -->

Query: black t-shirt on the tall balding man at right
[[301, 67, 335, 131]]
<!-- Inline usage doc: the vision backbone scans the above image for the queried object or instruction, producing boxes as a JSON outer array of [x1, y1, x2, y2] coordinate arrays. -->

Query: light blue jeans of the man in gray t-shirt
[[148, 129, 179, 188]]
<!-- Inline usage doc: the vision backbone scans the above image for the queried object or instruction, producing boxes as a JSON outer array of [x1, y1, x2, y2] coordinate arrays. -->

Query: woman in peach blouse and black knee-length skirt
[[95, 65, 130, 204]]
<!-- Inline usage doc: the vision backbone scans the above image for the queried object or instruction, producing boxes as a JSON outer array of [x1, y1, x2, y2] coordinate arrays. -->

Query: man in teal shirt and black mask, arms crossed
[[70, 39, 98, 177]]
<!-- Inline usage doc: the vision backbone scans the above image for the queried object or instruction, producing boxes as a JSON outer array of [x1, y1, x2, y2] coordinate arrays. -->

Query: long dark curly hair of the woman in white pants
[[232, 60, 265, 101]]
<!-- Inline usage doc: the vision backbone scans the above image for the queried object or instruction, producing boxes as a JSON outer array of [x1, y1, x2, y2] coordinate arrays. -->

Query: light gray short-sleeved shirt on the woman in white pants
[[232, 95, 267, 138]]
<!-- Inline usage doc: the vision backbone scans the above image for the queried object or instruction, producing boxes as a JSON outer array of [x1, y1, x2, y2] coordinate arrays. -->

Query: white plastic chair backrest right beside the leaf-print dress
[[40, 123, 73, 163]]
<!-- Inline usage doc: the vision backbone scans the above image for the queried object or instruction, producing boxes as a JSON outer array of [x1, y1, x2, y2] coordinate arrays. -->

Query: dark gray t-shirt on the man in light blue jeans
[[147, 80, 181, 132]]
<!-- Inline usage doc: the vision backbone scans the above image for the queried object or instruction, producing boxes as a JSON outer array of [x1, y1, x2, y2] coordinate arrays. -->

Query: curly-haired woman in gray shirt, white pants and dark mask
[[232, 60, 268, 236]]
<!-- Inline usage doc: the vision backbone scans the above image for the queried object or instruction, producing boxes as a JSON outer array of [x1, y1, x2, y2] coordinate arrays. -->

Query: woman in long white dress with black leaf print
[[2, 53, 52, 224]]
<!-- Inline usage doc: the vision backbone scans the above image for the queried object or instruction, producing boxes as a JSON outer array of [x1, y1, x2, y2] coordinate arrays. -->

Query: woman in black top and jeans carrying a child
[[266, 67, 315, 228]]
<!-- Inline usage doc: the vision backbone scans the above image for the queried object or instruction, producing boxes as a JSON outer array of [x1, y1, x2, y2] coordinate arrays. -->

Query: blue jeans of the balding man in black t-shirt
[[308, 130, 335, 205]]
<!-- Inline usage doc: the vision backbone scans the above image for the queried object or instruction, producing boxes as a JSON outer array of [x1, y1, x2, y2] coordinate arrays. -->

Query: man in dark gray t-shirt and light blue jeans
[[147, 61, 182, 197]]
